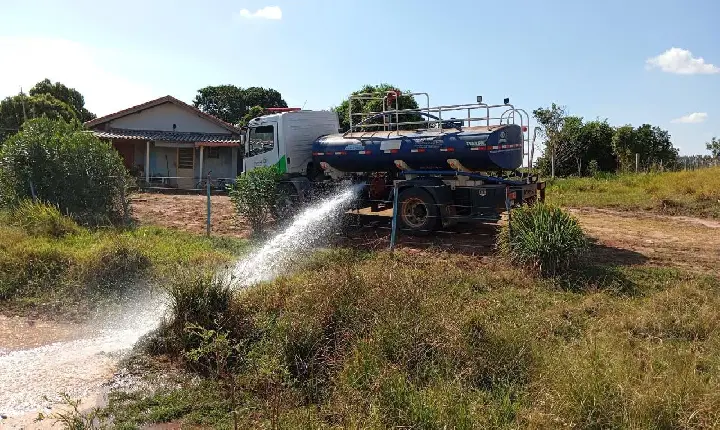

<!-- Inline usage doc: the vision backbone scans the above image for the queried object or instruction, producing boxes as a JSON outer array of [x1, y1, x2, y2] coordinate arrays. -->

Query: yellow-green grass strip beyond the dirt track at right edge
[[547, 167, 720, 219]]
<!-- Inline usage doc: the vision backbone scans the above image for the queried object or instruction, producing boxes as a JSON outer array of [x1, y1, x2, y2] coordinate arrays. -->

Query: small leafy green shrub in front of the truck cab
[[230, 166, 280, 233]]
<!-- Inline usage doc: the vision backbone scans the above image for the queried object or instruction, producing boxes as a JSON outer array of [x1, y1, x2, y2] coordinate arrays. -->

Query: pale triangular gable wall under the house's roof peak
[[110, 103, 229, 134]]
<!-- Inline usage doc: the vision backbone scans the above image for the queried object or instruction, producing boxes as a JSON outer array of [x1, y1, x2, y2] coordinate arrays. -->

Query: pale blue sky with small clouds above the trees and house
[[0, 0, 720, 154]]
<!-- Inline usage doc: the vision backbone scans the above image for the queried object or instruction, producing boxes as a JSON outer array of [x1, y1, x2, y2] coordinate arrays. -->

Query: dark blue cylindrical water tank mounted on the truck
[[312, 124, 523, 172]]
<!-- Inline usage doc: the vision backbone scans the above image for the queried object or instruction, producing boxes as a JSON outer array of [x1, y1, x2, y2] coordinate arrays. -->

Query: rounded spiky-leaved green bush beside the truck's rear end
[[497, 203, 588, 276]]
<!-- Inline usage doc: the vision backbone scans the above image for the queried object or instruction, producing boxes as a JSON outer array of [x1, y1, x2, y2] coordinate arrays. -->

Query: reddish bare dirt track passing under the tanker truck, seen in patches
[[133, 194, 720, 273]]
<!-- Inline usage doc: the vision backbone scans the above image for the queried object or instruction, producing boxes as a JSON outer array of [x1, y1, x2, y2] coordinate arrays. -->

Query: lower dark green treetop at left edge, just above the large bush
[[0, 94, 77, 145]]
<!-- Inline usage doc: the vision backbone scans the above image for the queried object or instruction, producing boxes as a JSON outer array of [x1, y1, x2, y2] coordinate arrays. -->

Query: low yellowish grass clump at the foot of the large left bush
[[10, 200, 80, 238]]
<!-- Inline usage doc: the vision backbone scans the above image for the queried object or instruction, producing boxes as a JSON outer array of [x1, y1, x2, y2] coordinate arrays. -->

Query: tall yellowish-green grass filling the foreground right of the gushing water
[[108, 250, 720, 429]]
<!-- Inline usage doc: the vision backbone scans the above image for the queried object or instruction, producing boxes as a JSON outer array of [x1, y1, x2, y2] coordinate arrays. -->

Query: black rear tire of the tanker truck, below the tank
[[398, 187, 440, 236]]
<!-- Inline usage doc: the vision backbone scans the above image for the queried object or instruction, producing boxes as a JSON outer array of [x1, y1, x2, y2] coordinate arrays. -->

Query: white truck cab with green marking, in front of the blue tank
[[243, 110, 340, 175]]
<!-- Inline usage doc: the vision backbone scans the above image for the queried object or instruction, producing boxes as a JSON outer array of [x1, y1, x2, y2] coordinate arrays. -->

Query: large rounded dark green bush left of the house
[[0, 118, 129, 225]]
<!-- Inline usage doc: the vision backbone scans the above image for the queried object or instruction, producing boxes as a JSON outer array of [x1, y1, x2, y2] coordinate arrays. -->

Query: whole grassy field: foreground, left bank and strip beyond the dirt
[[5, 169, 720, 429]]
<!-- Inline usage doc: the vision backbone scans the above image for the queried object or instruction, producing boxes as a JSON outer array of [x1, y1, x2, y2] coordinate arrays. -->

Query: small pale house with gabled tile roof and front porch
[[85, 96, 242, 189]]
